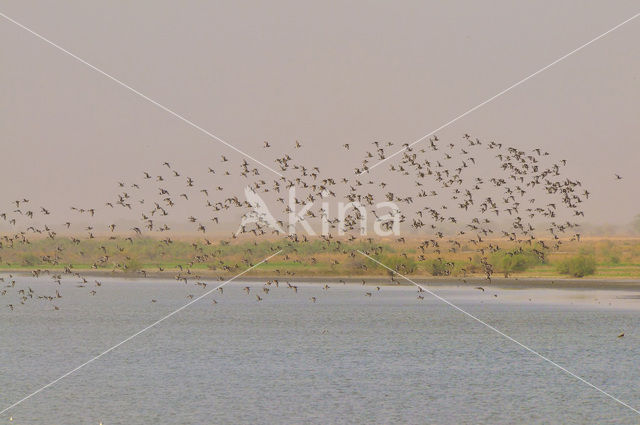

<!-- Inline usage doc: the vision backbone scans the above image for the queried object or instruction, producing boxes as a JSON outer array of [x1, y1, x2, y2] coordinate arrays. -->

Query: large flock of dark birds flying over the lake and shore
[[0, 134, 604, 310]]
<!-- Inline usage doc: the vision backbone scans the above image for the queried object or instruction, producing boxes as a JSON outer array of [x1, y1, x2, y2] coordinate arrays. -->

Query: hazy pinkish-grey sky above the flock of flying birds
[[0, 0, 640, 223]]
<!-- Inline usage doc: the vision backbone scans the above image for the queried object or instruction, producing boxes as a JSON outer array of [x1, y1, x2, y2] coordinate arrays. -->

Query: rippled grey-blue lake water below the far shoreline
[[0, 278, 640, 425]]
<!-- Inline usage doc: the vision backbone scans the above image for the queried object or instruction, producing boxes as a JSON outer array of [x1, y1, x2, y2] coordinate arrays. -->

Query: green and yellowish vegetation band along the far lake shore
[[0, 237, 640, 278]]
